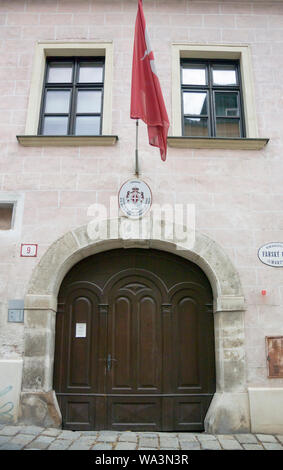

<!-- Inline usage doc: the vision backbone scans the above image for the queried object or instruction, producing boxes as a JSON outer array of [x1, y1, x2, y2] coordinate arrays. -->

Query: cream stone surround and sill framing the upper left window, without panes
[[18, 41, 115, 145]]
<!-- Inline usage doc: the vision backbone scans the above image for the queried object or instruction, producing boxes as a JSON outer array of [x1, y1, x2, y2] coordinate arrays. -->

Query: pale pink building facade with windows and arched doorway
[[0, 0, 283, 433]]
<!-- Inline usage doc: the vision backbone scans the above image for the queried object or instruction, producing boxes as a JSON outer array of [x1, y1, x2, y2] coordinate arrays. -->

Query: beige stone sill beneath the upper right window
[[167, 137, 269, 150]]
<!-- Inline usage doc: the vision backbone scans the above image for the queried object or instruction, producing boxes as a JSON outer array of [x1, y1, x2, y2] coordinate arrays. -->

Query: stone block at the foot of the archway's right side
[[204, 392, 251, 434]]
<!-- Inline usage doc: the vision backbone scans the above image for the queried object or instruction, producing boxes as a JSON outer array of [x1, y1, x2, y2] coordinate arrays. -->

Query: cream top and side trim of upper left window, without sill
[[25, 41, 113, 135]]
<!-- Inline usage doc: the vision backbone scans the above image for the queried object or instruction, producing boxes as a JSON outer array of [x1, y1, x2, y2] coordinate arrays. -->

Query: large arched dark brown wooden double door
[[54, 249, 215, 431]]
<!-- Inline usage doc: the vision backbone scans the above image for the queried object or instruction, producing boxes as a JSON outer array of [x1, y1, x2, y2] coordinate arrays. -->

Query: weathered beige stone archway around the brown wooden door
[[20, 218, 250, 433]]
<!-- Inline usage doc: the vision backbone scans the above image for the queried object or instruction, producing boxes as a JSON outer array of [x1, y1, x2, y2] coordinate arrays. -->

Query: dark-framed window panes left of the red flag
[[38, 57, 105, 136]]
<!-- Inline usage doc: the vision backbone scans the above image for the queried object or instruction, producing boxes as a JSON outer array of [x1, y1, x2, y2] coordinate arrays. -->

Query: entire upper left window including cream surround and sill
[[17, 41, 118, 147]]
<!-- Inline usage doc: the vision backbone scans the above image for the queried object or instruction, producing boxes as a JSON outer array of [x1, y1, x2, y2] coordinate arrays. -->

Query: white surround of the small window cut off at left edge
[[0, 191, 24, 243]]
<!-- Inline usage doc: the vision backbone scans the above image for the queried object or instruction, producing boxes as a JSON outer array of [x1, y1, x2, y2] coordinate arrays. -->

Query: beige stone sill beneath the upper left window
[[17, 135, 118, 147]]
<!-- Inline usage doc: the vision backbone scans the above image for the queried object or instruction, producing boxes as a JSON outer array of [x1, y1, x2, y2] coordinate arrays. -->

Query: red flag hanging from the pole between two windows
[[131, 0, 169, 160]]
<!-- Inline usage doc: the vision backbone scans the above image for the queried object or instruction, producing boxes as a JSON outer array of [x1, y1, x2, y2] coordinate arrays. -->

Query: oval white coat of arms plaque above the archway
[[118, 179, 152, 219]]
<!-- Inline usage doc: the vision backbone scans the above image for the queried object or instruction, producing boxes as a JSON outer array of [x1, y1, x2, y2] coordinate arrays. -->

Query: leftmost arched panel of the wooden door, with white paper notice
[[54, 288, 101, 393]]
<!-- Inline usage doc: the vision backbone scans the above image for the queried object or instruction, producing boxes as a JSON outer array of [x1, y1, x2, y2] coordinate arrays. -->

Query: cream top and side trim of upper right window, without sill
[[172, 43, 258, 138]]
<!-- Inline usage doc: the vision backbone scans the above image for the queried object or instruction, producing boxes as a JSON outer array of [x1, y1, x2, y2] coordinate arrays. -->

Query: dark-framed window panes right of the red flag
[[181, 59, 245, 138]]
